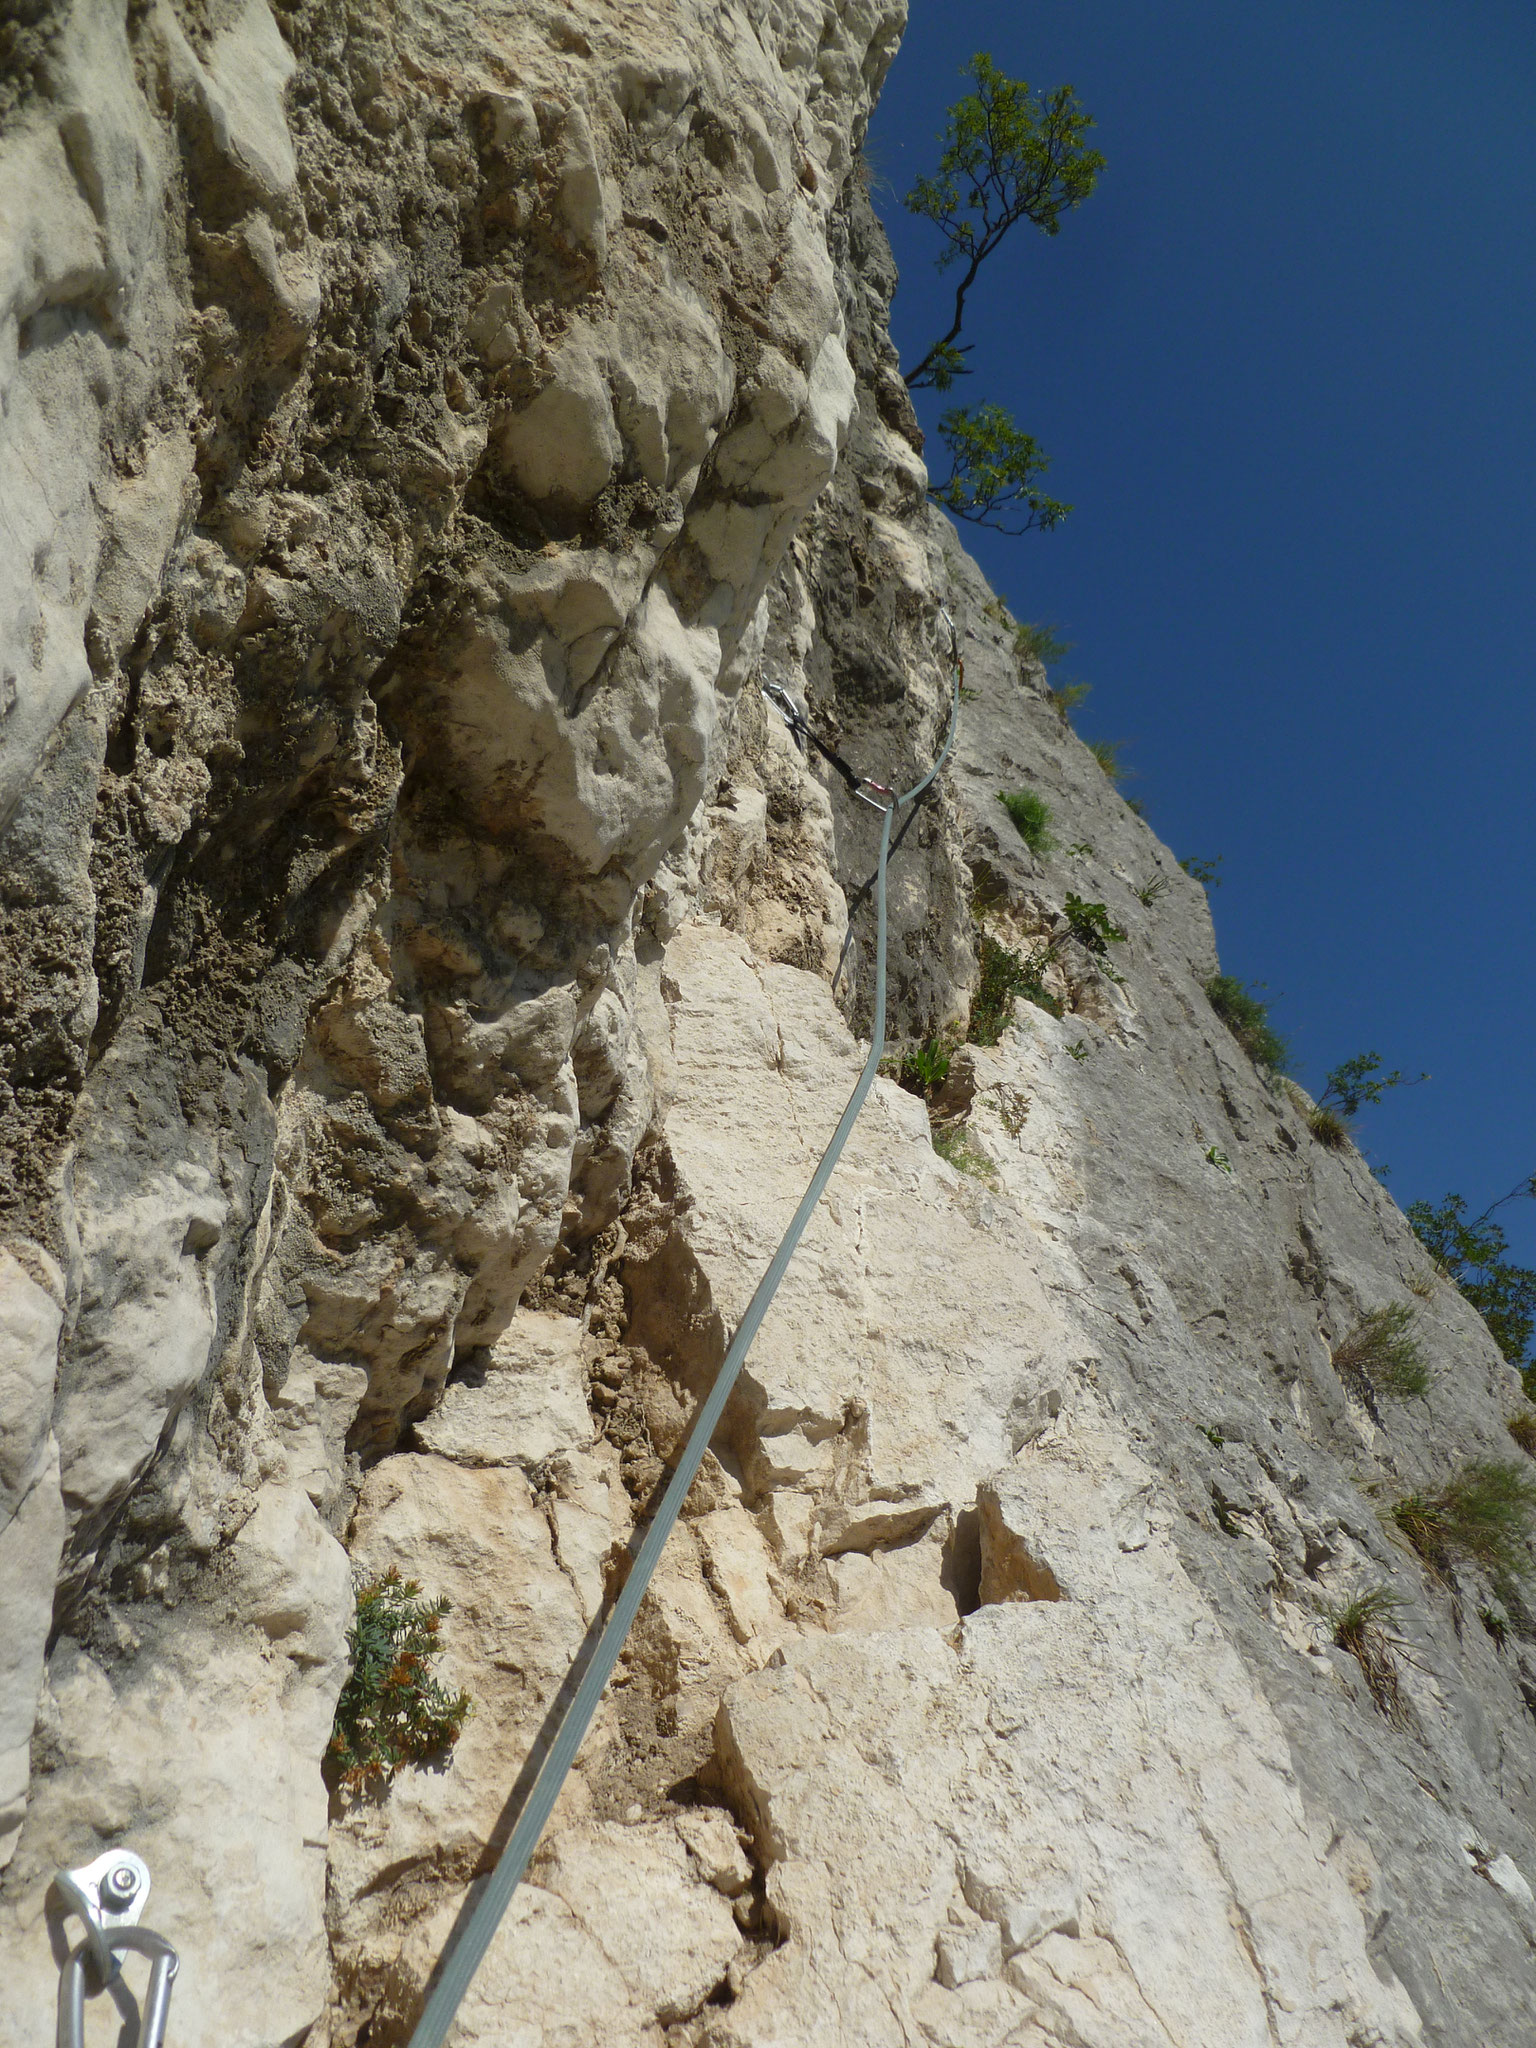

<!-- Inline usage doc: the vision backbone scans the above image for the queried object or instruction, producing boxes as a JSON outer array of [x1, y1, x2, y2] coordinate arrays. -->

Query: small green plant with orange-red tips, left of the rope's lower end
[[324, 1565, 473, 1792]]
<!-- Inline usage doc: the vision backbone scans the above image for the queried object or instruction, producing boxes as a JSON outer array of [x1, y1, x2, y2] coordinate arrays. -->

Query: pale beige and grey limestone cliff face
[[0, 0, 1536, 2048]]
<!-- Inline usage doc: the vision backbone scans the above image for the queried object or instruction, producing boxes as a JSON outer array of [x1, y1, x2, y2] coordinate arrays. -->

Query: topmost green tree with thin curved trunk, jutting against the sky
[[905, 51, 1104, 391]]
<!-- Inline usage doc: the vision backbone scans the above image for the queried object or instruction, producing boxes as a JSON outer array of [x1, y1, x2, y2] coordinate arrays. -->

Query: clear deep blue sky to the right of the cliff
[[870, 0, 1536, 1264]]
